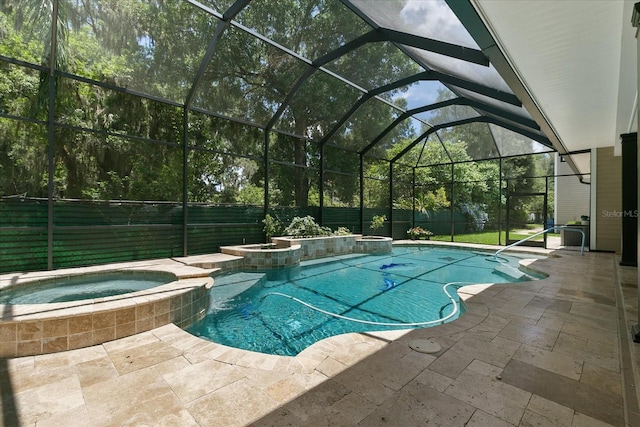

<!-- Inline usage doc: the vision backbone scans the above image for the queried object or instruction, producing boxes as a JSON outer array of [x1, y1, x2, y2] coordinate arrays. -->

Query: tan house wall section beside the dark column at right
[[591, 147, 622, 253]]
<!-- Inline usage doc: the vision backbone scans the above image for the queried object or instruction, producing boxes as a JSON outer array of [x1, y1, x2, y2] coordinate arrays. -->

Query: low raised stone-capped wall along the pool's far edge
[[220, 234, 393, 270]]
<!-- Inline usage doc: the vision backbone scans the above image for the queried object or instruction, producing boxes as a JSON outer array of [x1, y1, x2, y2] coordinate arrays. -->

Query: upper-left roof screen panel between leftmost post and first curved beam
[[65, 0, 211, 102]]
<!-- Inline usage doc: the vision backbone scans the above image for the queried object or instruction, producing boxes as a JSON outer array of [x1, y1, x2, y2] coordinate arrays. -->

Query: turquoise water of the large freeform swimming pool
[[188, 246, 531, 356]]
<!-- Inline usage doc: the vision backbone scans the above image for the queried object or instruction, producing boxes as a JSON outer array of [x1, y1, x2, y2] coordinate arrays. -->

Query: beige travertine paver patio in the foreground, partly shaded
[[0, 244, 640, 427]]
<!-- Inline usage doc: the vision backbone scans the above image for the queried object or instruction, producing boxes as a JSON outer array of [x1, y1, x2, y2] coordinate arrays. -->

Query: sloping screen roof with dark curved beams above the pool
[[0, 0, 552, 163]]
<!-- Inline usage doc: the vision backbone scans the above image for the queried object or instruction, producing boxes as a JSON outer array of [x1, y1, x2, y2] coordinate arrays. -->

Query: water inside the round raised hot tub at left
[[0, 272, 175, 304]]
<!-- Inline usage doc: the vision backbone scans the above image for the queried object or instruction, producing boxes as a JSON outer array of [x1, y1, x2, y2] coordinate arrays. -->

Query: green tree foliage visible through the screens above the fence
[[0, 0, 553, 218]]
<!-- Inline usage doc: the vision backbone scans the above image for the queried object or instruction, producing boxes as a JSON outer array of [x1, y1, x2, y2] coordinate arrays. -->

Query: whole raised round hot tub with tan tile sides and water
[[0, 266, 213, 357]]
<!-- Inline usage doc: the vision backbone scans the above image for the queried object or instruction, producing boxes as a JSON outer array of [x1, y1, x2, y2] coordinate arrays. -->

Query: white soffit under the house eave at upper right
[[474, 0, 637, 157]]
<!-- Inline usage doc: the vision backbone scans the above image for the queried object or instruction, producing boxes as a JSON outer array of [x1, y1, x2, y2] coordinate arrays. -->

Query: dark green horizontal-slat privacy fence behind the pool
[[0, 197, 471, 273]]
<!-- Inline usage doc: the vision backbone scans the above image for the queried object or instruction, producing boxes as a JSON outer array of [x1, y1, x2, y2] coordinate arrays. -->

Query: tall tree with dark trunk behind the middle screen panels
[[202, 0, 418, 207]]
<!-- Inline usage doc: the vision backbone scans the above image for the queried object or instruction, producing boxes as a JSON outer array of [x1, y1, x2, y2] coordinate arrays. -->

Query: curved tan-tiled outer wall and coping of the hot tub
[[0, 276, 213, 357]]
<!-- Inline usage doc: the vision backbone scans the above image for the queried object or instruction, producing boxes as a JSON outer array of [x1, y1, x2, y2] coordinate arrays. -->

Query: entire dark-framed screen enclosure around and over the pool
[[0, 0, 558, 272]]
